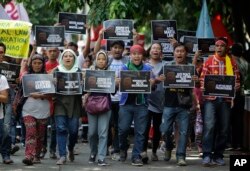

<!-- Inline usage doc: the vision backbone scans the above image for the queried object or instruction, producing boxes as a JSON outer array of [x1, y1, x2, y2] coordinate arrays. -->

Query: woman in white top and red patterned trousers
[[22, 54, 49, 165]]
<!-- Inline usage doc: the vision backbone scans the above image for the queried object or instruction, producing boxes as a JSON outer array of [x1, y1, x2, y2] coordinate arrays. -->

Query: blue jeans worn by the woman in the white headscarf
[[55, 115, 79, 157]]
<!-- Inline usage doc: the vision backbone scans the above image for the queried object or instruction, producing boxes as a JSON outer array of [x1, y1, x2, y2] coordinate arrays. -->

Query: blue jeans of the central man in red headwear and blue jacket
[[118, 104, 148, 160]]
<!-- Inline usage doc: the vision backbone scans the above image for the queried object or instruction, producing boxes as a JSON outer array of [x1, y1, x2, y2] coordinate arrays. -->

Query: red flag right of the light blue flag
[[212, 14, 234, 46]]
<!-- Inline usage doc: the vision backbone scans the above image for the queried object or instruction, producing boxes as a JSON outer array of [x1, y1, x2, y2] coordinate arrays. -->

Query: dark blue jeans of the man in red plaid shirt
[[202, 98, 231, 158]]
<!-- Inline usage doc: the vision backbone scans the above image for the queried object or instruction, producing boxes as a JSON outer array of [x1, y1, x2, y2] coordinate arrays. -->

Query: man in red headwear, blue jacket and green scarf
[[118, 45, 154, 166]]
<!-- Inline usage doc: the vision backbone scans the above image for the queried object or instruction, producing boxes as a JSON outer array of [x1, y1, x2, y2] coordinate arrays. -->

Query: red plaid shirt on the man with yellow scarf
[[200, 55, 240, 102]]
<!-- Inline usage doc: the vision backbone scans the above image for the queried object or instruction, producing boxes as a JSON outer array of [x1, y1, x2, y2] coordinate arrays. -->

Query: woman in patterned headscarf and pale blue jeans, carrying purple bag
[[85, 50, 111, 166]]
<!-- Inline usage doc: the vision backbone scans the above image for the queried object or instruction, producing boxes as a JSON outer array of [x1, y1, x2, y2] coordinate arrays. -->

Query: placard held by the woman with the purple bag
[[84, 70, 115, 93]]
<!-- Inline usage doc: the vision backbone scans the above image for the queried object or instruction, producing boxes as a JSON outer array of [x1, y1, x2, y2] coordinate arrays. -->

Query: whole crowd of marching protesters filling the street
[[0, 21, 249, 166]]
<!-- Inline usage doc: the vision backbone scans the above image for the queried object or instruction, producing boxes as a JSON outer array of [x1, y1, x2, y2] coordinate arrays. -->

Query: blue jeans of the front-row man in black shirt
[[160, 107, 189, 159]]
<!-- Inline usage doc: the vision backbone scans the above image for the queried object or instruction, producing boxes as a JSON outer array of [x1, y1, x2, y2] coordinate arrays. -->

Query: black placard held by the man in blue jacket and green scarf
[[120, 71, 151, 94]]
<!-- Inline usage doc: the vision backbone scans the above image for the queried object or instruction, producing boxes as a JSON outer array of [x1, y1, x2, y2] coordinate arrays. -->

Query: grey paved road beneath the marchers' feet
[[0, 143, 237, 171]]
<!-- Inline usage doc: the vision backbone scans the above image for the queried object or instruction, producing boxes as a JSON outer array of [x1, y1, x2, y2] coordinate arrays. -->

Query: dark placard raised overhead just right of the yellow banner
[[35, 26, 65, 47]]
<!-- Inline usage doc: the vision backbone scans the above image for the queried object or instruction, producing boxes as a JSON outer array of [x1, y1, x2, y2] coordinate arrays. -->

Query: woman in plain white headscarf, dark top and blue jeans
[[54, 49, 82, 165]]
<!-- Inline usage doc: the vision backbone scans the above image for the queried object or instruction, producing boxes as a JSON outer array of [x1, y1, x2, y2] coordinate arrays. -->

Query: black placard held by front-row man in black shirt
[[163, 65, 195, 88]]
